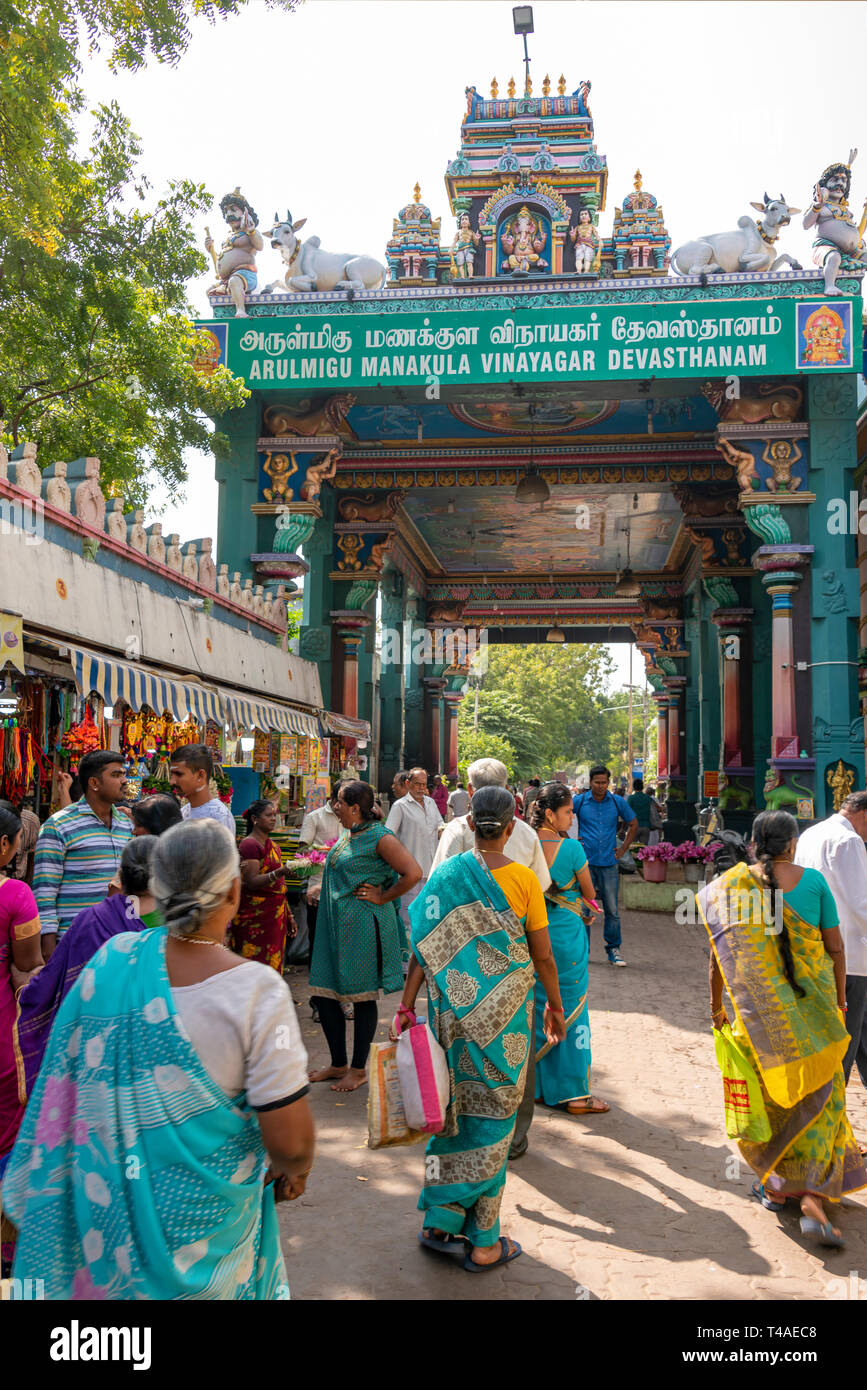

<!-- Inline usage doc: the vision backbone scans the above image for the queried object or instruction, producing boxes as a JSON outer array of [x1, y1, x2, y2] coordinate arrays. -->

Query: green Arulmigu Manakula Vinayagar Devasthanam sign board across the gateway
[[201, 297, 861, 386]]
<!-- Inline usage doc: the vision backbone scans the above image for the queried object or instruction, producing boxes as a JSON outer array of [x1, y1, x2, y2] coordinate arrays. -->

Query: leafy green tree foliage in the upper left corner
[[0, 0, 293, 505]]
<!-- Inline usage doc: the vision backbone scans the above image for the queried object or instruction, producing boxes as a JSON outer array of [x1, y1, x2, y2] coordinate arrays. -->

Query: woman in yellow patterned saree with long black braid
[[699, 810, 867, 1248]]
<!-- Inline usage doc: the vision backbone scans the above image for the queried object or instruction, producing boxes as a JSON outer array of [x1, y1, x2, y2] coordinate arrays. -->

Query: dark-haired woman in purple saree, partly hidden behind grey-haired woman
[[18, 835, 163, 1102]]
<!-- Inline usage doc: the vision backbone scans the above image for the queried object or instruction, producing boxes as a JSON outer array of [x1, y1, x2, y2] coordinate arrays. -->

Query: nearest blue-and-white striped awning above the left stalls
[[67, 644, 222, 724]]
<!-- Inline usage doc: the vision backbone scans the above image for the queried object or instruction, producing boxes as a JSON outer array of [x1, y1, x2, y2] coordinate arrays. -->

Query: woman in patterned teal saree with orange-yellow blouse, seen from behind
[[400, 787, 565, 1273]]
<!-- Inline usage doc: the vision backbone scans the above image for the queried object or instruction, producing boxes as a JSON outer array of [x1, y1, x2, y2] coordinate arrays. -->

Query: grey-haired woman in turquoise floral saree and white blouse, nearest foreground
[[3, 820, 314, 1300]]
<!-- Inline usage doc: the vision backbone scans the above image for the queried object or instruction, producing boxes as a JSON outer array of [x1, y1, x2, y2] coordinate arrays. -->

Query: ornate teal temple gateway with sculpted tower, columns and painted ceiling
[[194, 56, 867, 826]]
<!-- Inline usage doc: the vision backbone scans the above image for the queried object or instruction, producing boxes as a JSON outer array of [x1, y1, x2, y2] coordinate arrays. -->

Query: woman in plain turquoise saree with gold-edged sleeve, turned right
[[529, 783, 610, 1115]]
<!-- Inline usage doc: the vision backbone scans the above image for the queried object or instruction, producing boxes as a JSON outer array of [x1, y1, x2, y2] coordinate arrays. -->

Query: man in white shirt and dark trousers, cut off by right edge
[[795, 791, 867, 1086]]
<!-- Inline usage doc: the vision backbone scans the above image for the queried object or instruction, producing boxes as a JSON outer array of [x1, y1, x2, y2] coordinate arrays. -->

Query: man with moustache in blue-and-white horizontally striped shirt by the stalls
[[33, 749, 132, 960]]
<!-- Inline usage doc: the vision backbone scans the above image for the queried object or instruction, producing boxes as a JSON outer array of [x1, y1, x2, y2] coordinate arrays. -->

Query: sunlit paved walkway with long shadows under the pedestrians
[[278, 913, 867, 1300]]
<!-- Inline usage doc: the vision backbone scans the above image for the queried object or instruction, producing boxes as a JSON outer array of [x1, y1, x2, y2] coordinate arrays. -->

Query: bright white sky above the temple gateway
[[85, 0, 867, 692]]
